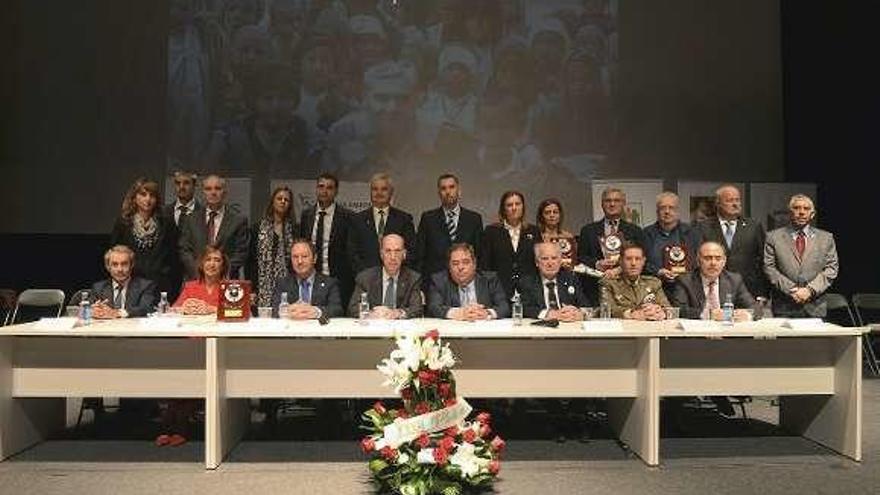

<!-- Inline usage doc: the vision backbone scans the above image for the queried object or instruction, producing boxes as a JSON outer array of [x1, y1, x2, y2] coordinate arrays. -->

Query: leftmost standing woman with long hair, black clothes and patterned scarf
[[110, 177, 180, 301]]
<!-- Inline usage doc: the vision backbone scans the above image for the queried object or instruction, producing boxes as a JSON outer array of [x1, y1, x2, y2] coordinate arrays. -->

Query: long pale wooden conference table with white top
[[0, 317, 868, 469]]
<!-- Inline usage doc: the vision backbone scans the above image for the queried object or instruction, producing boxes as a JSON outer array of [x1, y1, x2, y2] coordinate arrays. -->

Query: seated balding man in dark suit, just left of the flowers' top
[[348, 234, 423, 320]]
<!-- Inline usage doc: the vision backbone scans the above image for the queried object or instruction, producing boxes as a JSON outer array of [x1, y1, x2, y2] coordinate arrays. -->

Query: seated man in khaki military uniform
[[600, 244, 670, 321]]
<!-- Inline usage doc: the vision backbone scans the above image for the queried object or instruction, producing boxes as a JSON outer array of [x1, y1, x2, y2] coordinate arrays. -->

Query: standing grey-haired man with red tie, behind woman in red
[[178, 175, 249, 280]]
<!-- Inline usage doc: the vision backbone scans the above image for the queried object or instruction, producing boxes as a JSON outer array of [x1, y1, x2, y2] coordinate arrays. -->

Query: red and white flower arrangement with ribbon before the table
[[361, 330, 505, 495]]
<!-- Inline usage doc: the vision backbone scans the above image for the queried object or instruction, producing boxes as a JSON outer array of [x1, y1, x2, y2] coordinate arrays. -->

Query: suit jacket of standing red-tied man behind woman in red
[[179, 205, 250, 279]]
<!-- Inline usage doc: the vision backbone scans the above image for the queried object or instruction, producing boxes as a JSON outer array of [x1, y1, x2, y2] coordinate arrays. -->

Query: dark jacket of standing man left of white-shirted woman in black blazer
[[415, 208, 483, 284]]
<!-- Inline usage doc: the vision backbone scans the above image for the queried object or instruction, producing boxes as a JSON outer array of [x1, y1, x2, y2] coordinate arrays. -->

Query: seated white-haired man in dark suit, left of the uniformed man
[[522, 242, 588, 321]]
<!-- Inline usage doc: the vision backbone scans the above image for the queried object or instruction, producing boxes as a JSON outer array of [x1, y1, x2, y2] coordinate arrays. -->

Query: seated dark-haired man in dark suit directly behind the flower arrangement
[[427, 242, 510, 321]]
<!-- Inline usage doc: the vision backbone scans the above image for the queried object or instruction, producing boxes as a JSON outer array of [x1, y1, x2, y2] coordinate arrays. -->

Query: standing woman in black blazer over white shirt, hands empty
[[479, 191, 541, 298]]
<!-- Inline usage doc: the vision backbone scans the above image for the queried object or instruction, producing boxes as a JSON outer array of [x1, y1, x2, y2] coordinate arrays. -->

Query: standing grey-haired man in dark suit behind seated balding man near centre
[[349, 173, 416, 276]]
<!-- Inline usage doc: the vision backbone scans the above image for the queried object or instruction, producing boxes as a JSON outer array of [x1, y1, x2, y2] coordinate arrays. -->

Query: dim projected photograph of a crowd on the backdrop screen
[[167, 0, 617, 218]]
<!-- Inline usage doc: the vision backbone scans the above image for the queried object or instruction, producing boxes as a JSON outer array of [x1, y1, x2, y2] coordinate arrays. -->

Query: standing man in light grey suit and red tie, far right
[[764, 194, 838, 317]]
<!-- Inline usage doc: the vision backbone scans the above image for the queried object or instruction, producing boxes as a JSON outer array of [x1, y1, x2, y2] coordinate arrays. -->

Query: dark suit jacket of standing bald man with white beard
[[700, 217, 769, 297]]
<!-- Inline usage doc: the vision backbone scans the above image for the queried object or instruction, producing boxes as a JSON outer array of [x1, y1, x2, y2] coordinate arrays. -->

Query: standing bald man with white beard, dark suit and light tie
[[700, 184, 768, 297]]
